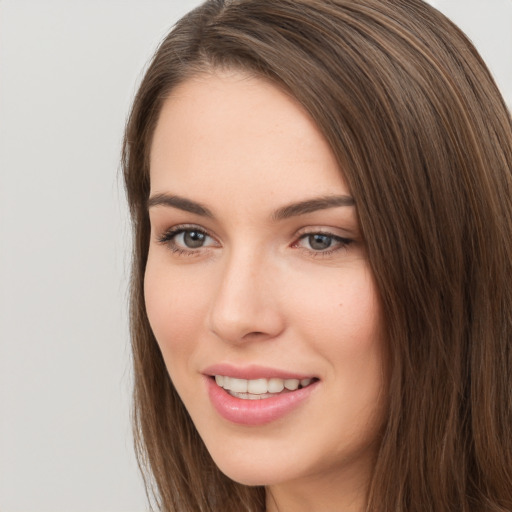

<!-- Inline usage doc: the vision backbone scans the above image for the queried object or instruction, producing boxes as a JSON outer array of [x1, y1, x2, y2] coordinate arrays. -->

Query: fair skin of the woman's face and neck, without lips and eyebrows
[[145, 71, 387, 512]]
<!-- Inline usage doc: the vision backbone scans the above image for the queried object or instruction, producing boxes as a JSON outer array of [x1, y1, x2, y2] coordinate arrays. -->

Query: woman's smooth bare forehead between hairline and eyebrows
[[150, 72, 347, 209]]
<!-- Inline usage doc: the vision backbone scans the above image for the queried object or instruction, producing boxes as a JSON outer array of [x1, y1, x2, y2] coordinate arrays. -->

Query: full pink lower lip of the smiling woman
[[206, 377, 318, 426]]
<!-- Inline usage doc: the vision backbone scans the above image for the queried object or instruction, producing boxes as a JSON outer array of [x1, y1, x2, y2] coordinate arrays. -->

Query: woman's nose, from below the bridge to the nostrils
[[209, 251, 285, 343]]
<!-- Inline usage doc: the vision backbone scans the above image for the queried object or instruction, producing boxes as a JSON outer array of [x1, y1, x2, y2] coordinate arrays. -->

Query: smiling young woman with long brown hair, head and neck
[[123, 0, 512, 512]]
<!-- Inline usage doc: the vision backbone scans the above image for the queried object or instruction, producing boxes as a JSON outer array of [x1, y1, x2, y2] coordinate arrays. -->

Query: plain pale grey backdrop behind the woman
[[0, 0, 512, 512]]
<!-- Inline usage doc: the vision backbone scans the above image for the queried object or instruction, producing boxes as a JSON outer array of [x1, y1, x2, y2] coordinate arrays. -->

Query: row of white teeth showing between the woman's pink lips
[[215, 375, 313, 399]]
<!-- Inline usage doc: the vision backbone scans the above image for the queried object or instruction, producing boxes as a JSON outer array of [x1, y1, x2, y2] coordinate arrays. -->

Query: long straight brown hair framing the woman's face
[[123, 0, 512, 512]]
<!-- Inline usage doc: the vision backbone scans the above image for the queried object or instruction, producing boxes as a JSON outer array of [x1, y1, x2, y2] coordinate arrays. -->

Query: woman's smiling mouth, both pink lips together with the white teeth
[[203, 365, 319, 426]]
